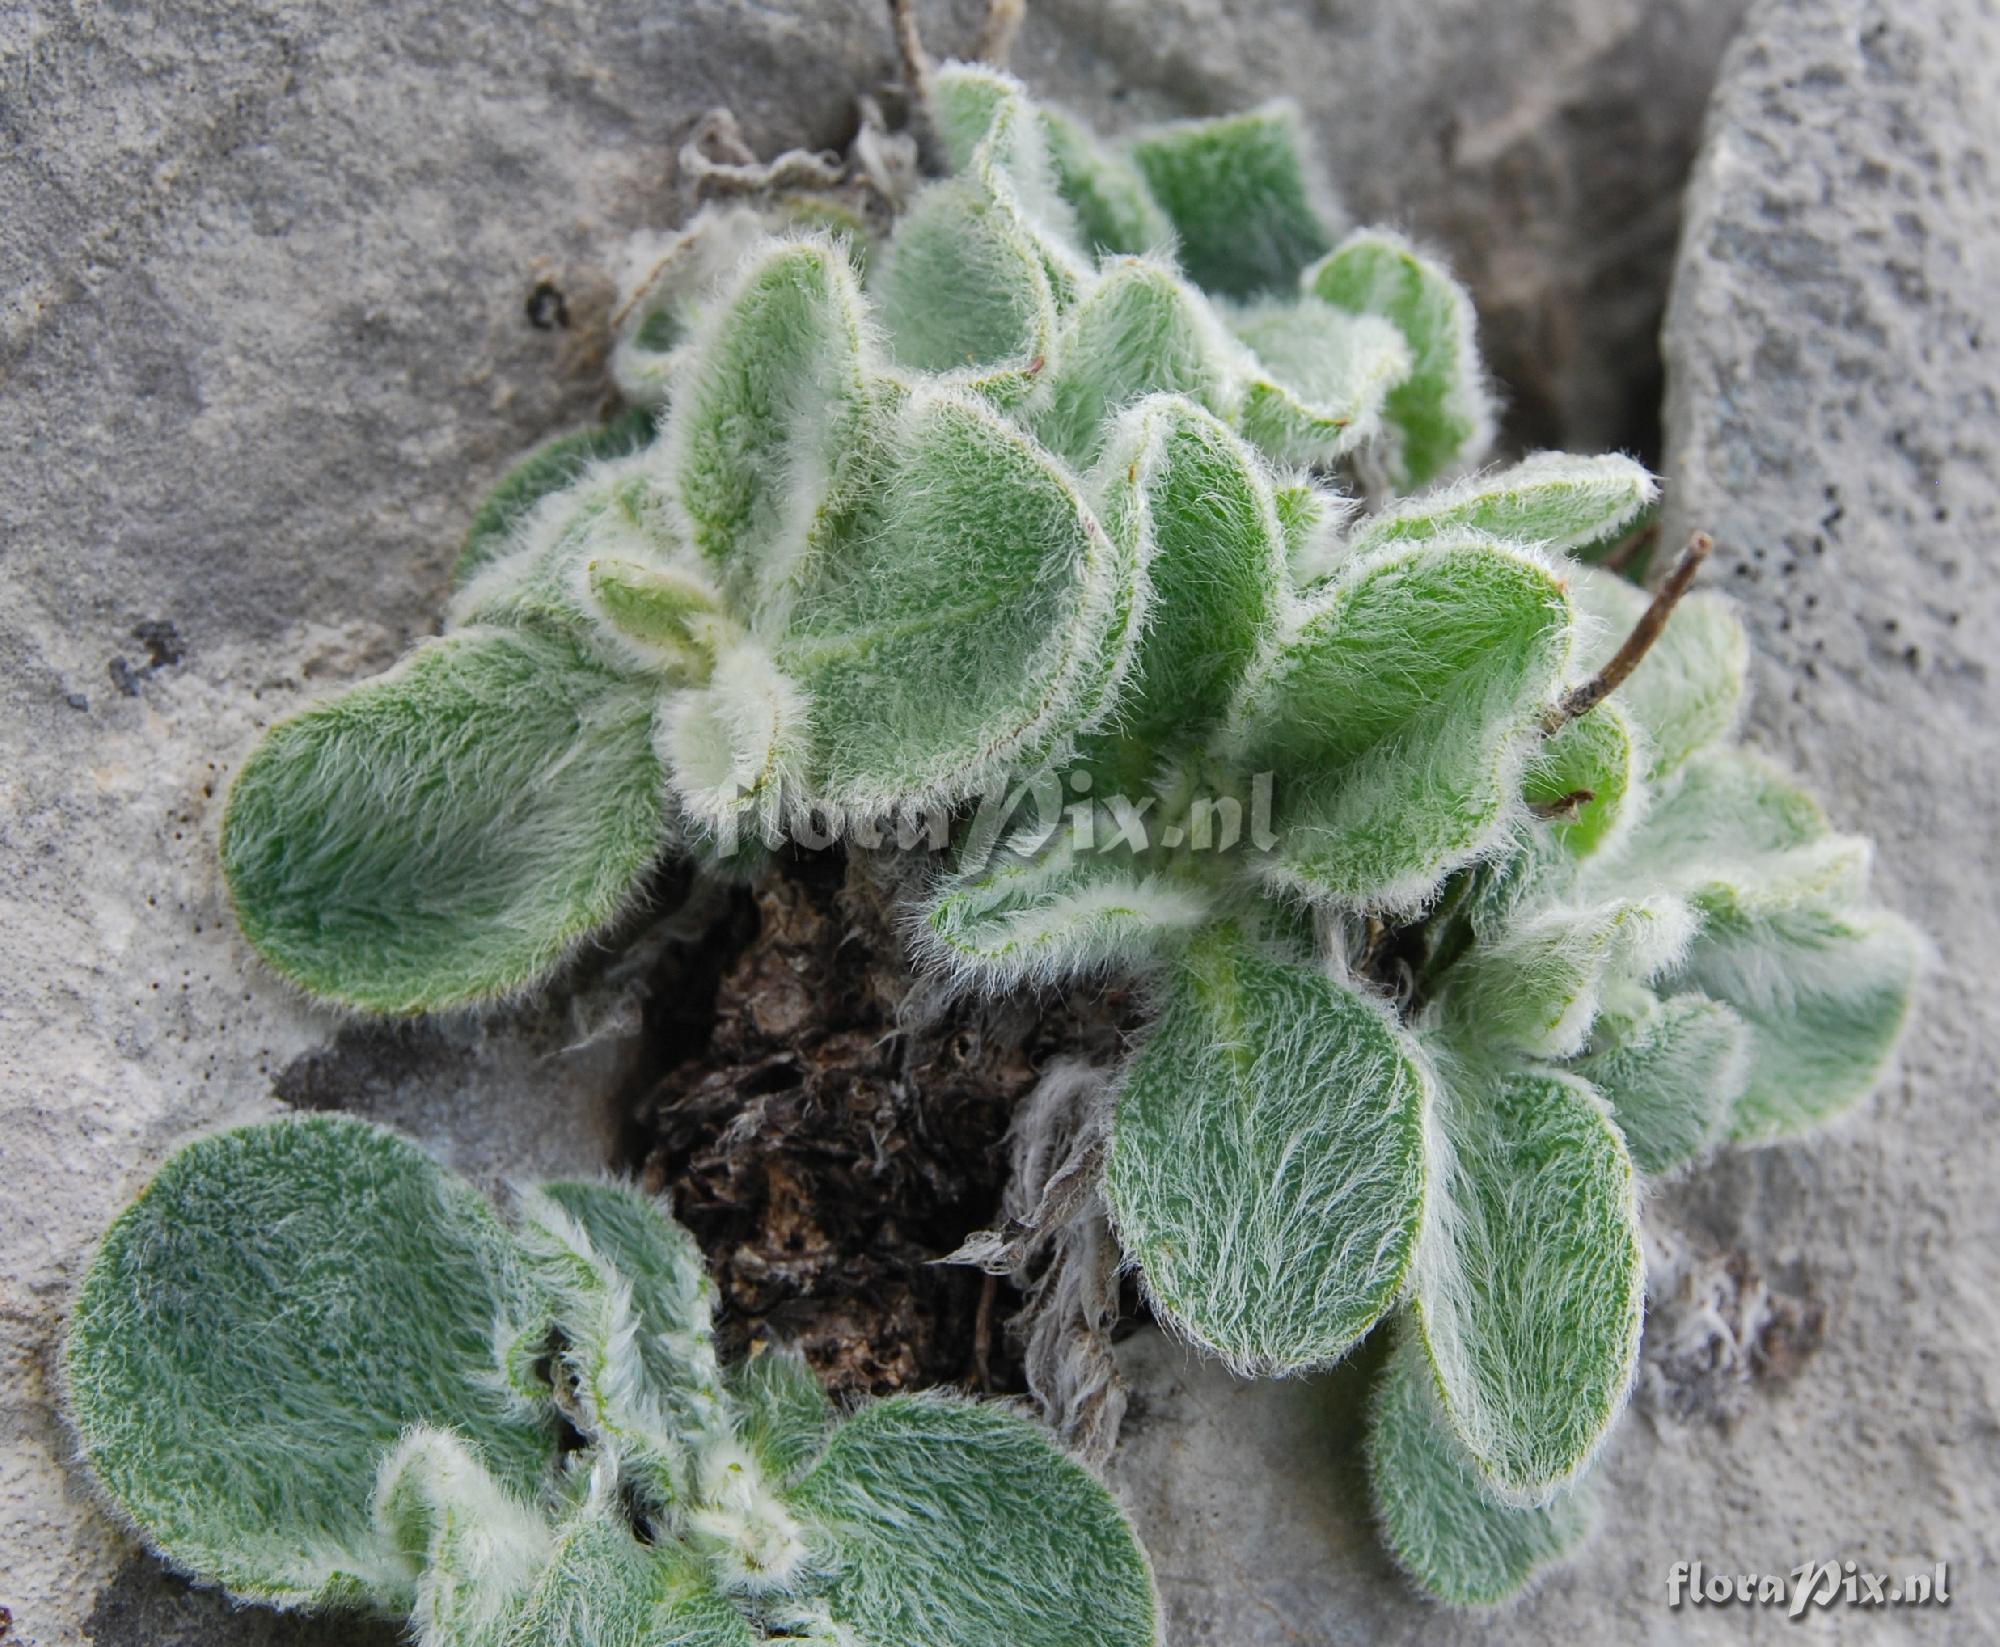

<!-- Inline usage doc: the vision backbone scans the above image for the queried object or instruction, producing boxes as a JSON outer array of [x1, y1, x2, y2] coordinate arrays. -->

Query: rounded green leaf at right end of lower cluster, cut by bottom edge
[[790, 1395, 1158, 1647]]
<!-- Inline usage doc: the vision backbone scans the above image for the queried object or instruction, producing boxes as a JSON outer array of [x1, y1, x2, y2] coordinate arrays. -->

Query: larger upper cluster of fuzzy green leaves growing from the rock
[[211, 66, 1918, 1601]]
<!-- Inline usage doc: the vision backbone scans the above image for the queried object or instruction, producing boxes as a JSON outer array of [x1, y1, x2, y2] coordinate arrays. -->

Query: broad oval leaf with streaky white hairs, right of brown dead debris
[[1104, 927, 1428, 1369]]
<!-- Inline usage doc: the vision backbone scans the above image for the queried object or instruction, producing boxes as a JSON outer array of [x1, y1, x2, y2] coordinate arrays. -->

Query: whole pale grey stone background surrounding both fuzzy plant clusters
[[0, 0, 2000, 1647]]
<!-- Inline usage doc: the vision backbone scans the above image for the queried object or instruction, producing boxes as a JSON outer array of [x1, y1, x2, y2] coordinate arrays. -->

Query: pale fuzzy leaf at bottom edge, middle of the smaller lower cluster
[[504, 1511, 758, 1647]]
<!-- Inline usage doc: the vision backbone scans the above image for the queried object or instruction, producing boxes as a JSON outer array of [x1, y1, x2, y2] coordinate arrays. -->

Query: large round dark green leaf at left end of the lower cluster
[[60, 1113, 554, 1607]]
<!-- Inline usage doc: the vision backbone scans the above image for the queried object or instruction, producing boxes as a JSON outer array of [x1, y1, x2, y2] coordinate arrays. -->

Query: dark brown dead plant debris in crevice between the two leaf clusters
[[632, 853, 1136, 1395]]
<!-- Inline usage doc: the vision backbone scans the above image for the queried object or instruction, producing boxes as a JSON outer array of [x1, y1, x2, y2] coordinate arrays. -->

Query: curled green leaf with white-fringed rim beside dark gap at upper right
[[1304, 230, 1492, 492]]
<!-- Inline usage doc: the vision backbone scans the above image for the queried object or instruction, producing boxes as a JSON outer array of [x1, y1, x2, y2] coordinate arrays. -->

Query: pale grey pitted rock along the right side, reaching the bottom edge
[[1114, 0, 2000, 1647]]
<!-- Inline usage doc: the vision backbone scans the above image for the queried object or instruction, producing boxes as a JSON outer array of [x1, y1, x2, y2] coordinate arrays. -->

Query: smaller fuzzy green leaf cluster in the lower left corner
[[62, 1115, 1158, 1647]]
